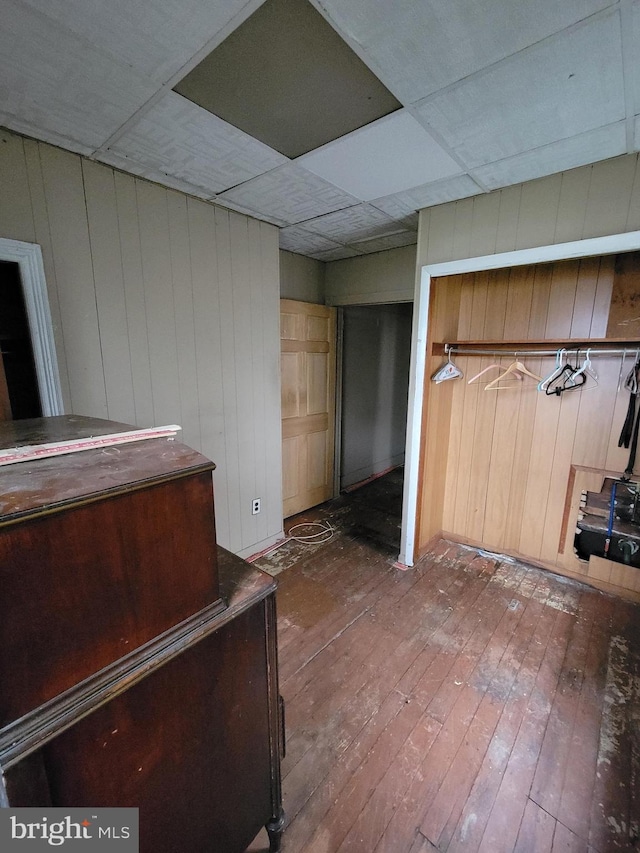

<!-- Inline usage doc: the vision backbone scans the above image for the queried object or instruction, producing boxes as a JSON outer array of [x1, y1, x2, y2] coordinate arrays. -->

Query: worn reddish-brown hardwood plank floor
[[250, 476, 640, 853]]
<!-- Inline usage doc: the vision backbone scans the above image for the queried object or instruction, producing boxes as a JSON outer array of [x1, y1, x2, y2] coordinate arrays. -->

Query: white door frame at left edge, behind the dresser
[[0, 237, 64, 417]]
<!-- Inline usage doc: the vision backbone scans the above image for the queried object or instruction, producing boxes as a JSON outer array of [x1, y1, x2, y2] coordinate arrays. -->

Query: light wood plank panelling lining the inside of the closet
[[417, 256, 640, 591]]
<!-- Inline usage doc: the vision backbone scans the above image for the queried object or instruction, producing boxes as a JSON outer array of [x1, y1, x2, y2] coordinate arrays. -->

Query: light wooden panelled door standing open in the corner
[[280, 299, 336, 518]]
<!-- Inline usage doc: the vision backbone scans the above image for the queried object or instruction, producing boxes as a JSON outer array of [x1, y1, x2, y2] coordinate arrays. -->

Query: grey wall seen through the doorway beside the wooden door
[[340, 303, 412, 488]]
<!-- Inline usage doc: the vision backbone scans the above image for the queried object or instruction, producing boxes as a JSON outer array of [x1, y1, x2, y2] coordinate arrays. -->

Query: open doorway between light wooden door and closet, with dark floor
[[339, 302, 413, 548]]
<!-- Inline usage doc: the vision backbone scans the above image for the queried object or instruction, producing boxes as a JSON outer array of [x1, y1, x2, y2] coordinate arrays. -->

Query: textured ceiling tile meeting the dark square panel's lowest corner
[[219, 163, 358, 225]]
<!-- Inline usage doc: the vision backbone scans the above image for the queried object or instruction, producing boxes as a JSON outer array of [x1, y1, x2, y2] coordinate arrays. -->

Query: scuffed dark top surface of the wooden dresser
[[0, 415, 215, 524]]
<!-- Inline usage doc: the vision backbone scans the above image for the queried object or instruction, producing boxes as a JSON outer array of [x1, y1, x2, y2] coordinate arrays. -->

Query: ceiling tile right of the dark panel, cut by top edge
[[312, 0, 611, 105]]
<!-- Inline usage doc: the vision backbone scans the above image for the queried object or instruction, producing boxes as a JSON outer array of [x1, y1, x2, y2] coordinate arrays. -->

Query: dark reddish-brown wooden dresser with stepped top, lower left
[[0, 416, 284, 853]]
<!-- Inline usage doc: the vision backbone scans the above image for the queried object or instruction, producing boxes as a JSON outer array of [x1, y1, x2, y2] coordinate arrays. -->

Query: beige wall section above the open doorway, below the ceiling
[[325, 241, 416, 305]]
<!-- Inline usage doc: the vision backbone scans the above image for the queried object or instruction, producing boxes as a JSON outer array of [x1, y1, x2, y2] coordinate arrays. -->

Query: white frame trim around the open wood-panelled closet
[[398, 231, 640, 566]]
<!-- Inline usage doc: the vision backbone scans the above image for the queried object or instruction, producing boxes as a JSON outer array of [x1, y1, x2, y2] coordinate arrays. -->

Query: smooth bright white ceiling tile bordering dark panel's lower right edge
[[296, 110, 462, 201]]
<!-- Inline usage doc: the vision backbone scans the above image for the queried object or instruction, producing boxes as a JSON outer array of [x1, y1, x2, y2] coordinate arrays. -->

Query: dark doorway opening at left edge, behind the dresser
[[0, 261, 42, 420]]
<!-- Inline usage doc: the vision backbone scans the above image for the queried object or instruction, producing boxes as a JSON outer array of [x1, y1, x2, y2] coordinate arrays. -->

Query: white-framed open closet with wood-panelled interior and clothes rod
[[400, 232, 640, 596]]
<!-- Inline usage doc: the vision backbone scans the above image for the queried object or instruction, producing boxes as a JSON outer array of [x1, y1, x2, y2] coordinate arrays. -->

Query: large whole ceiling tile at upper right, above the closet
[[414, 13, 625, 168]]
